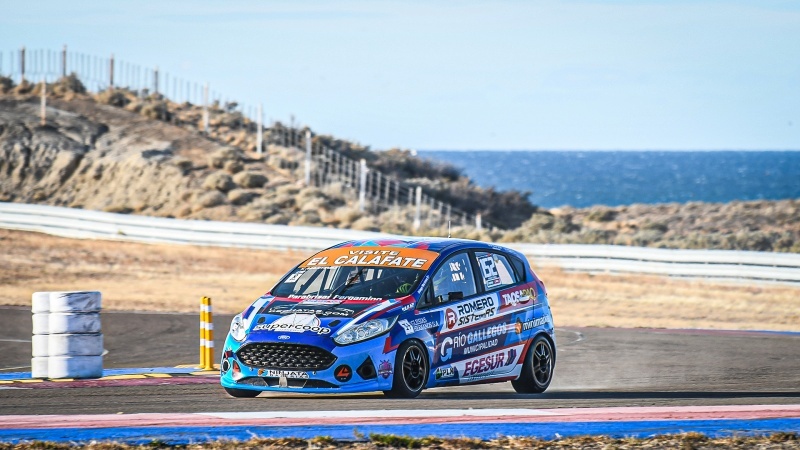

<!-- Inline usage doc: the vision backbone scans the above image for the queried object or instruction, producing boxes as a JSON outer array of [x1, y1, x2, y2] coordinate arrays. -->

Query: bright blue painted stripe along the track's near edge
[[0, 418, 800, 444]]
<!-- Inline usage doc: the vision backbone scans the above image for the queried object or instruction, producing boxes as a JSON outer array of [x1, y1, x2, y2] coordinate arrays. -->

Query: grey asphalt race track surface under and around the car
[[0, 307, 800, 414]]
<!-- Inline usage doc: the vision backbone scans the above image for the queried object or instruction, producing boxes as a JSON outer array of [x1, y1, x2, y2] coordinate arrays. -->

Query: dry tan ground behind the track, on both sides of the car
[[0, 230, 800, 331]]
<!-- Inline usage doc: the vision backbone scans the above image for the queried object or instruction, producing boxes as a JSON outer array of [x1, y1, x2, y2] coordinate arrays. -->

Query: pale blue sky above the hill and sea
[[0, 0, 800, 150]]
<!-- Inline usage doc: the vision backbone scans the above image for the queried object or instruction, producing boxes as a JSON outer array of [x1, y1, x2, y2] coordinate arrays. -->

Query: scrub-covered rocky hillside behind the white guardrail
[[0, 77, 800, 253]]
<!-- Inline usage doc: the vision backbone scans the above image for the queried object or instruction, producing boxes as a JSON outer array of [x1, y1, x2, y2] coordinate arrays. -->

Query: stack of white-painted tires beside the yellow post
[[31, 291, 103, 378]]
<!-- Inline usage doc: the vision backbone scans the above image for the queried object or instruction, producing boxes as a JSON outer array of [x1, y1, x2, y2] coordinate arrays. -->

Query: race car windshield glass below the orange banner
[[272, 266, 425, 300]]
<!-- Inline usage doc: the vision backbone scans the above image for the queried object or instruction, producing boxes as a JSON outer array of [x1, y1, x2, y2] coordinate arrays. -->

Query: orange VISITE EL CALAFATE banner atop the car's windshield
[[300, 247, 439, 270]]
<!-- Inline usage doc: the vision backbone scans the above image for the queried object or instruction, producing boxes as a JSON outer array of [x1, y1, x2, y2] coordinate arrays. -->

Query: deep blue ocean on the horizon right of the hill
[[417, 150, 800, 208]]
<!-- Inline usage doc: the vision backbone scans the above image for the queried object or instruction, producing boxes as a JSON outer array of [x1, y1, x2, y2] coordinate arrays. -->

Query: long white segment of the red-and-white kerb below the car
[[199, 409, 562, 419]]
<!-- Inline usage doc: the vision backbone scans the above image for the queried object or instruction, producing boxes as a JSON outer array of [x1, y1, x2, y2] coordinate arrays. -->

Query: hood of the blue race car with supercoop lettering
[[245, 296, 402, 341]]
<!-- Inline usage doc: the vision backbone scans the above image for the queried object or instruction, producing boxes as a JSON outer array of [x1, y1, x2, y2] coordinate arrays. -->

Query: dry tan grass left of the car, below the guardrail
[[0, 230, 307, 313]]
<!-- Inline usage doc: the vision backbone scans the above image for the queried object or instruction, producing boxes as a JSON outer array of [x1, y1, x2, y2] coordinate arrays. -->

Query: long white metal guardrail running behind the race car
[[0, 203, 800, 285]]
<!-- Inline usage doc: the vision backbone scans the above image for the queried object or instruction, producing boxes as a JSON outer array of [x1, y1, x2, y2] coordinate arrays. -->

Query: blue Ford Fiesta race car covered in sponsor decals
[[220, 239, 556, 398]]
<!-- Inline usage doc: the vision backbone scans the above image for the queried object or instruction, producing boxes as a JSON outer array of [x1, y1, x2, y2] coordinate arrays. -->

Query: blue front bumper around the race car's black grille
[[220, 335, 396, 394]]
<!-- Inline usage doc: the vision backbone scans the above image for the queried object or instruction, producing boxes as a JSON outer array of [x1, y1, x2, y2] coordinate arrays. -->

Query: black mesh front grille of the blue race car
[[236, 342, 336, 370]]
